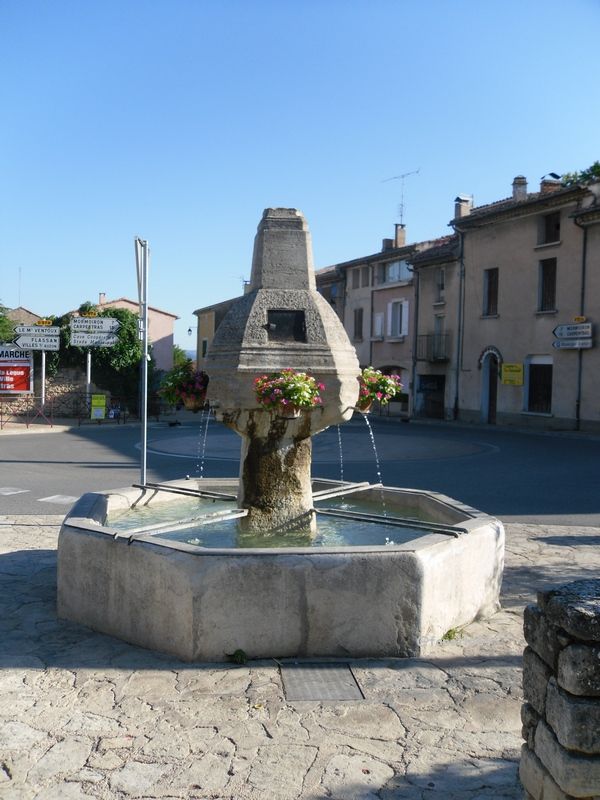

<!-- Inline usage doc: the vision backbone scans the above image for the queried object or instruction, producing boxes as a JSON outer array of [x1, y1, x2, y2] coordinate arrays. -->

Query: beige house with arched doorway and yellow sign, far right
[[451, 176, 600, 430]]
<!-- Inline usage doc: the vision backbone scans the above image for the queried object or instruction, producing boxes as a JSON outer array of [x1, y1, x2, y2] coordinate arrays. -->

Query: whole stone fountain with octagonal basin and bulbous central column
[[58, 209, 504, 661]]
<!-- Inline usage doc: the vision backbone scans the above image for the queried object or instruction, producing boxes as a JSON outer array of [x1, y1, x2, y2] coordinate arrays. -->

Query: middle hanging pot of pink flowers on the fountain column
[[254, 369, 325, 417]]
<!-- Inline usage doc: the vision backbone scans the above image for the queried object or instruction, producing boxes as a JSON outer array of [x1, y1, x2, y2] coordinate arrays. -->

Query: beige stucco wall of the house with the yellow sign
[[460, 206, 600, 428]]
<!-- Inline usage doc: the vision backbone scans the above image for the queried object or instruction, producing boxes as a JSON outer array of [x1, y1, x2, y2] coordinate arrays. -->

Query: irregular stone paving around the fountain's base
[[0, 517, 600, 800]]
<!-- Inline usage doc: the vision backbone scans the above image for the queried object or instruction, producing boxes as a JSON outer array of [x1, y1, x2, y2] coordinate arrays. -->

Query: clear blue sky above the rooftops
[[0, 0, 600, 348]]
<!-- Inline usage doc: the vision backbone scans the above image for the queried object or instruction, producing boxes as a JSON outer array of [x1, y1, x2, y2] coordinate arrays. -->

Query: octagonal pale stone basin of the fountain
[[58, 479, 504, 661]]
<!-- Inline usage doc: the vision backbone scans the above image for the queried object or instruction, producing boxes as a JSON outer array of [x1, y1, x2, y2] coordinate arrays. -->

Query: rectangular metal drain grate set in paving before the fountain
[[280, 663, 365, 700]]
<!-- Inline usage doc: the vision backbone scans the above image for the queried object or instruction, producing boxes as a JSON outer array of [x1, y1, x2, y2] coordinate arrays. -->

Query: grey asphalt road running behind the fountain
[[0, 415, 600, 525]]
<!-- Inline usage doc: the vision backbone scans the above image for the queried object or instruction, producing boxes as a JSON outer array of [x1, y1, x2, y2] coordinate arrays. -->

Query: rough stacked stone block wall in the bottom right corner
[[519, 580, 600, 800]]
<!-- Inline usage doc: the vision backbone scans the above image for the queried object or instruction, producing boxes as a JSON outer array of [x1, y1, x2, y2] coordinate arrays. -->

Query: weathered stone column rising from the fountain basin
[[206, 208, 360, 531]]
